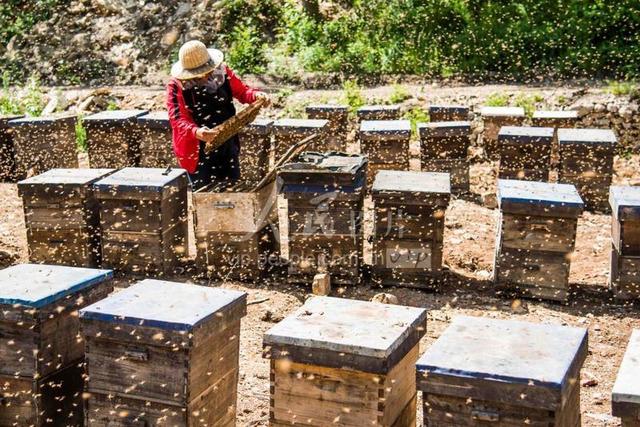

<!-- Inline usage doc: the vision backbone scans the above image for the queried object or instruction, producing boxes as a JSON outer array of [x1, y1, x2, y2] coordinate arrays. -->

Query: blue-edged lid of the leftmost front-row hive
[[0, 264, 113, 308]]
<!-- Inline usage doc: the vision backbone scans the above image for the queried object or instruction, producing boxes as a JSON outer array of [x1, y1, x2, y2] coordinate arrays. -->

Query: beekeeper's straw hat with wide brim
[[171, 40, 224, 80]]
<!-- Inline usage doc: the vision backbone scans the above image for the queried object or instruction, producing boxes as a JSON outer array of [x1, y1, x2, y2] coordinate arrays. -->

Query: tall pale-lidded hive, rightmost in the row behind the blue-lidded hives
[[558, 129, 617, 210]]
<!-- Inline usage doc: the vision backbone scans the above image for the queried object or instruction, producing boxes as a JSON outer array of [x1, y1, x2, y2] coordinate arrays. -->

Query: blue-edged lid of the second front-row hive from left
[[80, 279, 247, 331]]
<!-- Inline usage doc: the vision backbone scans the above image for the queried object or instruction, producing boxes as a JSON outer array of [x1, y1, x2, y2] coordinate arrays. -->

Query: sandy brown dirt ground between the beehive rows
[[0, 82, 640, 426]]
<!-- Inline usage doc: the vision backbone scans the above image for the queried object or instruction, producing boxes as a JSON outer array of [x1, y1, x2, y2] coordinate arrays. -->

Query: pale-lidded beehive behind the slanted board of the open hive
[[271, 119, 329, 161]]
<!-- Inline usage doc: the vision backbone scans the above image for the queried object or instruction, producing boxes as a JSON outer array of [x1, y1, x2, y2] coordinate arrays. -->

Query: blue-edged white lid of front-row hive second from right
[[416, 316, 587, 389]]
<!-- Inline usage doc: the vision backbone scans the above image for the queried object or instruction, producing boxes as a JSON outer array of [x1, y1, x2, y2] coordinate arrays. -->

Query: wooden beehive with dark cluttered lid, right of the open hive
[[282, 152, 367, 285]]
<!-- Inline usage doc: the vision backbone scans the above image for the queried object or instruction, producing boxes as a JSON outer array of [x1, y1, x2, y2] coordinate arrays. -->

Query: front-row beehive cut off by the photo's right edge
[[611, 329, 640, 427]]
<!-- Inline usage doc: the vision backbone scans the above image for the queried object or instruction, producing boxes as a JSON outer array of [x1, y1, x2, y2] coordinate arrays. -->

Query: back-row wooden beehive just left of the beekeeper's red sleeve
[[137, 111, 178, 168]]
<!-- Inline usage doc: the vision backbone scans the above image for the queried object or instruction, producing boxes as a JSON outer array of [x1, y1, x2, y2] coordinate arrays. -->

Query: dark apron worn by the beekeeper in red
[[184, 78, 240, 191]]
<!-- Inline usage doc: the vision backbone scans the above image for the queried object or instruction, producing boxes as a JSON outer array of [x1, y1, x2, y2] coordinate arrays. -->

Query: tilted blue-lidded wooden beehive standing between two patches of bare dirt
[[494, 179, 584, 302]]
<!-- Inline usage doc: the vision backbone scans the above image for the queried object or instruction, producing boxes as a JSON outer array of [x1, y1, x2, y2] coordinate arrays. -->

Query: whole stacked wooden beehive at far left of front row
[[0, 264, 113, 427]]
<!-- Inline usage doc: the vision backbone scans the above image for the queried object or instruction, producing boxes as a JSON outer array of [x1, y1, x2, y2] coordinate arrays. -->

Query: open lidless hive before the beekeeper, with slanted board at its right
[[193, 134, 319, 281]]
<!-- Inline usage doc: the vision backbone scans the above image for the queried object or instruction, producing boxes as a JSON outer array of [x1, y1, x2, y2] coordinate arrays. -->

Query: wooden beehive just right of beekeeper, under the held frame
[[238, 118, 273, 186]]
